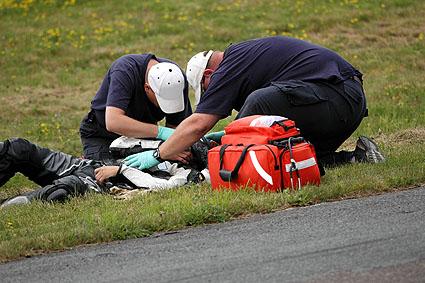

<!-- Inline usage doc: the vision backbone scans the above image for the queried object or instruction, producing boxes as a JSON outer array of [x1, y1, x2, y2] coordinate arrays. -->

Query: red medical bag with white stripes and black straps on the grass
[[208, 115, 320, 191]]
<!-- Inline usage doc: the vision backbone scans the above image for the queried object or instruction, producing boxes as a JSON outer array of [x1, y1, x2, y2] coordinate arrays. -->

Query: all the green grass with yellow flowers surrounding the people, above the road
[[0, 0, 425, 262]]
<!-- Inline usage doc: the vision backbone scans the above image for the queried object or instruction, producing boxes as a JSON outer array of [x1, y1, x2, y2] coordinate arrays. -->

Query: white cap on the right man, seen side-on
[[186, 50, 213, 105]]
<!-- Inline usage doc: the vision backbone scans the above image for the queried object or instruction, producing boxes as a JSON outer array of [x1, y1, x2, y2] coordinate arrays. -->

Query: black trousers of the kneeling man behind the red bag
[[236, 78, 367, 167]]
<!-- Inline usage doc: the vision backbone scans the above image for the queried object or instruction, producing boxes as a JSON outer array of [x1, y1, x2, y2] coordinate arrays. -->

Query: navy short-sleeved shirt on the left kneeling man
[[91, 54, 192, 127]]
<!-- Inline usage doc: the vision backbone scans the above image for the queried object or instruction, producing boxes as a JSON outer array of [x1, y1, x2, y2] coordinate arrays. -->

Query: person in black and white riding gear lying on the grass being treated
[[0, 138, 208, 207]]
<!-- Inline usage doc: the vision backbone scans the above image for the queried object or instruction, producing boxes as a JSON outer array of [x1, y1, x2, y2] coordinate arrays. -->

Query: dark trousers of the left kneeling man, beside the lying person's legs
[[80, 110, 119, 162]]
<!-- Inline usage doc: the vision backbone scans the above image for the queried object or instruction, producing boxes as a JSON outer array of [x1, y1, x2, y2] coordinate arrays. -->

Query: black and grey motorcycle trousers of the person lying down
[[0, 138, 101, 201]]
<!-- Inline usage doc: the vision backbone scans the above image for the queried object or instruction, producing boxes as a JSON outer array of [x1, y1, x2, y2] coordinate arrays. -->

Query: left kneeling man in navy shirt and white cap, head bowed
[[80, 54, 192, 162]]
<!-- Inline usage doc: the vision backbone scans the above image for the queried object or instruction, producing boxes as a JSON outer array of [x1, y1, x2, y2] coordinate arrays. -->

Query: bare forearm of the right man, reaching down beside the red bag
[[160, 113, 219, 159]]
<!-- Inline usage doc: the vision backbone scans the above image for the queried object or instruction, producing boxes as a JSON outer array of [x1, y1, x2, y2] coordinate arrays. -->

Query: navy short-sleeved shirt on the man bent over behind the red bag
[[195, 36, 361, 117]]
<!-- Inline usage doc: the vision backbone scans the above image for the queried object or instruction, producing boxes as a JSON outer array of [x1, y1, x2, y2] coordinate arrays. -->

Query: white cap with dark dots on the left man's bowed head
[[148, 62, 184, 114]]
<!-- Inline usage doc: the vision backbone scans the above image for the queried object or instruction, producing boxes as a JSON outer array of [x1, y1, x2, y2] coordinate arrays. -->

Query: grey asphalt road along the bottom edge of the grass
[[0, 188, 425, 282]]
